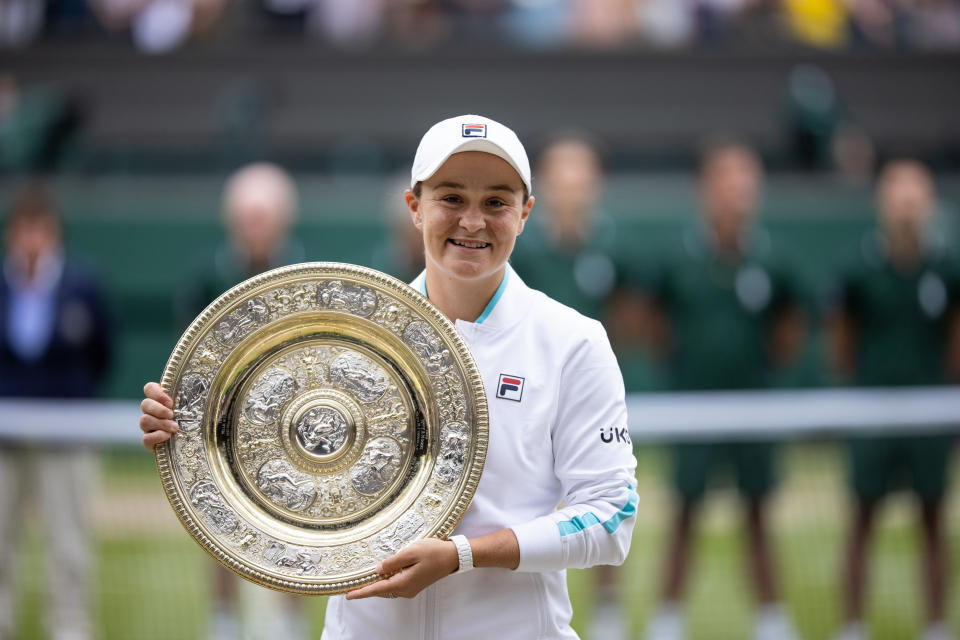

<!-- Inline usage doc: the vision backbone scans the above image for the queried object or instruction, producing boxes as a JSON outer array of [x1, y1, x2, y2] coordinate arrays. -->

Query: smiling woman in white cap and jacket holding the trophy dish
[[141, 115, 637, 640]]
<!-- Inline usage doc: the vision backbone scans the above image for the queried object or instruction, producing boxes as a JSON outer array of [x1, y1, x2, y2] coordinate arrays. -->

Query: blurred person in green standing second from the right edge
[[637, 141, 807, 640]]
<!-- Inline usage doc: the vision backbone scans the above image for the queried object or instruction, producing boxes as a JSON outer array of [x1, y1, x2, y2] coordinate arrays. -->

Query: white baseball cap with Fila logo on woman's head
[[410, 115, 533, 193]]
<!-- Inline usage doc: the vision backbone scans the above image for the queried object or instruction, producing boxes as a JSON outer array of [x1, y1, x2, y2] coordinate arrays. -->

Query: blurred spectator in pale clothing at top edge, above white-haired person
[[89, 0, 227, 54]]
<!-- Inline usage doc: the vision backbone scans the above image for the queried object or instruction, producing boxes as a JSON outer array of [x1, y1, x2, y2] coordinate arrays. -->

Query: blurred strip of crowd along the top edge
[[0, 0, 960, 53]]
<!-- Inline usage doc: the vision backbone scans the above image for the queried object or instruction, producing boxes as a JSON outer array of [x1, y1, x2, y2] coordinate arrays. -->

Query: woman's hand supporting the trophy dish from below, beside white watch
[[347, 538, 460, 600]]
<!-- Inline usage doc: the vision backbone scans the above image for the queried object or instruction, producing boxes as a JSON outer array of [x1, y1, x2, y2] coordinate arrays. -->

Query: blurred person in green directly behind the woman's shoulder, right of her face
[[512, 135, 616, 319]]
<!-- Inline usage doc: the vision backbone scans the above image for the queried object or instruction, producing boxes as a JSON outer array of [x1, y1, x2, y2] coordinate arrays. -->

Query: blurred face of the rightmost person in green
[[877, 162, 934, 239]]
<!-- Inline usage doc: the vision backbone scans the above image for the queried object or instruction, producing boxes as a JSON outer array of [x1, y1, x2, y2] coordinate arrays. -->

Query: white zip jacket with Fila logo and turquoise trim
[[323, 266, 637, 640]]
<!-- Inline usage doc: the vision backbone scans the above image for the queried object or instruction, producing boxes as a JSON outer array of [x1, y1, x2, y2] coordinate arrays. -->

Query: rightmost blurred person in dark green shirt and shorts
[[830, 160, 960, 640]]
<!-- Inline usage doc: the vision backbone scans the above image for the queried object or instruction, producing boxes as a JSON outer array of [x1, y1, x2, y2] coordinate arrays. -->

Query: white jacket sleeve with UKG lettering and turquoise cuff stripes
[[511, 322, 638, 572]]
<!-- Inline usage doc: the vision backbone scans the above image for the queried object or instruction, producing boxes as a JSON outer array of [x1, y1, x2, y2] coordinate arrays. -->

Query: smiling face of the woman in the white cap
[[406, 151, 533, 281]]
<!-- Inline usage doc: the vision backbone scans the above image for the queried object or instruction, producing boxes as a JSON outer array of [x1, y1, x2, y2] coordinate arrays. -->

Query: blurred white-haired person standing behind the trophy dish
[[174, 163, 308, 640]]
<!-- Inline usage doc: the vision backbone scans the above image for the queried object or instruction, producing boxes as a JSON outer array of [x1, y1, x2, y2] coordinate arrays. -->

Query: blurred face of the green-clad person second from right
[[700, 147, 760, 241]]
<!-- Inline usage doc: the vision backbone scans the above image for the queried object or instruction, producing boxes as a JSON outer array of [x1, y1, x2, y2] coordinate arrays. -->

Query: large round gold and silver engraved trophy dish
[[156, 263, 488, 593]]
